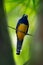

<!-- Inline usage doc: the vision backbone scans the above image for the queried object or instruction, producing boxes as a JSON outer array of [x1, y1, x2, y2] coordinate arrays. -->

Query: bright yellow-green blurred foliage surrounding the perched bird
[[4, 0, 39, 65]]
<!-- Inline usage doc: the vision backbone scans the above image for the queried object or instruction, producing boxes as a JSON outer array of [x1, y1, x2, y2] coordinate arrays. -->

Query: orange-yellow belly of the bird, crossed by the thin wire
[[17, 24, 27, 40]]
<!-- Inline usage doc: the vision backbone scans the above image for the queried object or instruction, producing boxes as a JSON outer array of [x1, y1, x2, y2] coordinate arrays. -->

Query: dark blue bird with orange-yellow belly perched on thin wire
[[16, 14, 29, 55]]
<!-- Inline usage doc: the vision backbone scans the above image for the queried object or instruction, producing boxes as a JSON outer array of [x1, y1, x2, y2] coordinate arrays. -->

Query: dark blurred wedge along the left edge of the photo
[[0, 0, 15, 65]]
